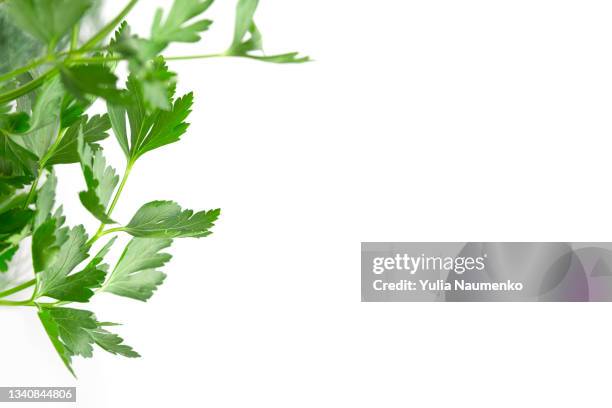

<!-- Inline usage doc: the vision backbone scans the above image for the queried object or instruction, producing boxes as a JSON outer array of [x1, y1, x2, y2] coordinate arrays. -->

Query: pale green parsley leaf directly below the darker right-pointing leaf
[[103, 238, 172, 301]]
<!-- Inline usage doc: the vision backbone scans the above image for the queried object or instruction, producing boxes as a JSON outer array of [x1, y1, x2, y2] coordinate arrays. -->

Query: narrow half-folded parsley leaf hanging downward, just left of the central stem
[[78, 129, 119, 224]]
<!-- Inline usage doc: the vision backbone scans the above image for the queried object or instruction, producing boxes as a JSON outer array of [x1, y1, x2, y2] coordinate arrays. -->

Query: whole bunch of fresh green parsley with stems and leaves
[[0, 0, 308, 375]]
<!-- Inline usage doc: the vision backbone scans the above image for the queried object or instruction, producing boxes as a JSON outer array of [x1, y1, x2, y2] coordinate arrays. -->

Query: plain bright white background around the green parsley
[[0, 0, 612, 408]]
